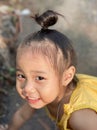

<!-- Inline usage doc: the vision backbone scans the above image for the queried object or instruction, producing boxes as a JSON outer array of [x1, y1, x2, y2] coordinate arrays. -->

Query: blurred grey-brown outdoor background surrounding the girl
[[0, 0, 97, 130]]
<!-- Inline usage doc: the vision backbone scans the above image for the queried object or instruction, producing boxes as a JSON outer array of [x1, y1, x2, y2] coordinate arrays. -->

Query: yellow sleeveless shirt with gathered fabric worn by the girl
[[46, 74, 97, 130]]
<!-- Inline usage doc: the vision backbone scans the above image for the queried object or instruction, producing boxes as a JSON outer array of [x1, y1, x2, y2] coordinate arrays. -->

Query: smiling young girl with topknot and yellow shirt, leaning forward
[[3, 10, 97, 130]]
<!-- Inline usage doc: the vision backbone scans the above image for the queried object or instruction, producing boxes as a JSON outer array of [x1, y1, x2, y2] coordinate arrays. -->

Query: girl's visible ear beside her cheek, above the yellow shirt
[[62, 66, 75, 86]]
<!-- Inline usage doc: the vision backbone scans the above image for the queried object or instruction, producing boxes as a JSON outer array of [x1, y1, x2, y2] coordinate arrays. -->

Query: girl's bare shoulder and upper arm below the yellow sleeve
[[69, 109, 97, 130]]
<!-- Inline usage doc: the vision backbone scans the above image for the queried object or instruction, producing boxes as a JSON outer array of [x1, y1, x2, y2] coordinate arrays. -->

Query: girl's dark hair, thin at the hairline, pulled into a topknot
[[17, 10, 77, 83]]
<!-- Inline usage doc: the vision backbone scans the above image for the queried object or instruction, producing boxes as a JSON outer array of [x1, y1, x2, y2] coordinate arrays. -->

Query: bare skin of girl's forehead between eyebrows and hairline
[[16, 47, 52, 69]]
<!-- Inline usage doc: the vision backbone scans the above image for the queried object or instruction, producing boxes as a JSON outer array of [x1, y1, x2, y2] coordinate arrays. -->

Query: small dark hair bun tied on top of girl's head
[[34, 10, 58, 29]]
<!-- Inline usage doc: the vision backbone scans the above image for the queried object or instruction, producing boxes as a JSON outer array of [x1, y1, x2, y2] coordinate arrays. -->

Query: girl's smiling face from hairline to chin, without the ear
[[16, 48, 63, 109]]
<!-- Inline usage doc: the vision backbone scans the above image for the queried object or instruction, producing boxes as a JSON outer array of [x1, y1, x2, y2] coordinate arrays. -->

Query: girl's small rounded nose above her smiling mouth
[[22, 82, 36, 96]]
